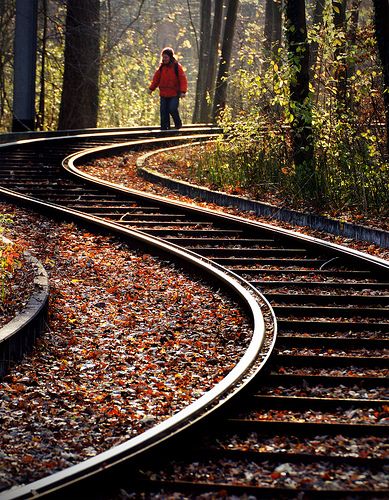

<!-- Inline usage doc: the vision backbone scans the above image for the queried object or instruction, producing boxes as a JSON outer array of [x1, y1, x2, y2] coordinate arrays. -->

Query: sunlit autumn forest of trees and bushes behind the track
[[0, 0, 389, 216]]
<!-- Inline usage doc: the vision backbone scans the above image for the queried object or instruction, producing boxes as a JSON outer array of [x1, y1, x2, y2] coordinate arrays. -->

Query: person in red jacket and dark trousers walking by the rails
[[149, 47, 188, 130]]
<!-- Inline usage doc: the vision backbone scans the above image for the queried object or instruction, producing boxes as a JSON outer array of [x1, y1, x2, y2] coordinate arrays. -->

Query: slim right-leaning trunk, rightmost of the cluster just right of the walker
[[212, 0, 239, 120]]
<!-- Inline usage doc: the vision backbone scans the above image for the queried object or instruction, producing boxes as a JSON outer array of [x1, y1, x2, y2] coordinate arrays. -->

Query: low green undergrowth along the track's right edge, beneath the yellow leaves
[[191, 123, 389, 215]]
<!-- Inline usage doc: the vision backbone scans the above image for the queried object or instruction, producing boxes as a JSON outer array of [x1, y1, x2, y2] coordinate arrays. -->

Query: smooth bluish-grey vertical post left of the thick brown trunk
[[12, 0, 38, 132]]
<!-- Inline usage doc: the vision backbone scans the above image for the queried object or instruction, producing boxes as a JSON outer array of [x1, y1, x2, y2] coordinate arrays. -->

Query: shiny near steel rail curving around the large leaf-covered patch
[[0, 130, 274, 500]]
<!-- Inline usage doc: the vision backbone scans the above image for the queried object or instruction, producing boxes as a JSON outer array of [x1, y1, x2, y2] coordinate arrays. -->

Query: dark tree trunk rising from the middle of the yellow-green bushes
[[285, 0, 315, 196]]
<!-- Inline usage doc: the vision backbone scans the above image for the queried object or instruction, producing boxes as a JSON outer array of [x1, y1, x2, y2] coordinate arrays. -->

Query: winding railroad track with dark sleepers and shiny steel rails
[[0, 129, 389, 499]]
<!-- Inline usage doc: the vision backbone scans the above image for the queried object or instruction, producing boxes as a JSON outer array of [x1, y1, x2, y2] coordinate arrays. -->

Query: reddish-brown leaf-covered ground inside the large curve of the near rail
[[0, 204, 251, 489]]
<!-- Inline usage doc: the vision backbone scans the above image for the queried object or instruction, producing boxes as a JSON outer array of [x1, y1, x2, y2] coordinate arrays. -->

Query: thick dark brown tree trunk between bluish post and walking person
[[58, 0, 100, 130]]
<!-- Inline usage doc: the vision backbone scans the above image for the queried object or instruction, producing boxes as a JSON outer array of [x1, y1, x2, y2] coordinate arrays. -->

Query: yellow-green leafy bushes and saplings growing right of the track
[[198, 1, 389, 214]]
